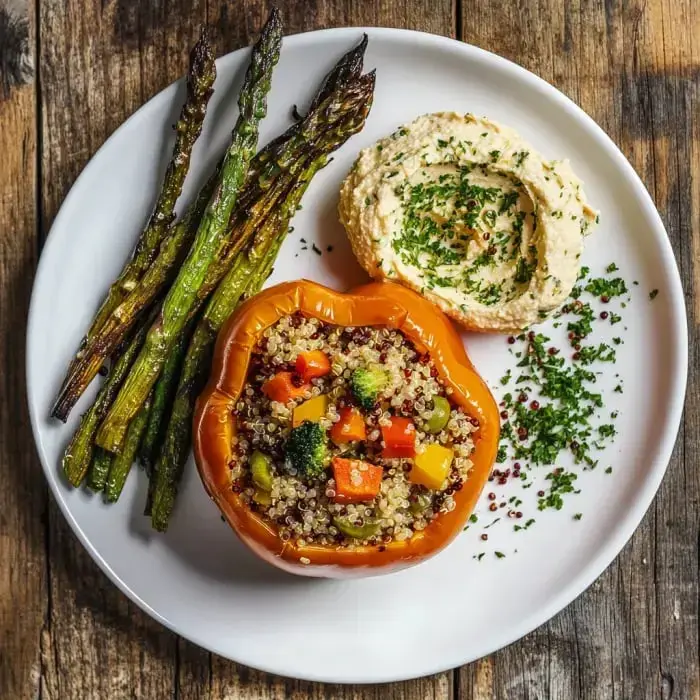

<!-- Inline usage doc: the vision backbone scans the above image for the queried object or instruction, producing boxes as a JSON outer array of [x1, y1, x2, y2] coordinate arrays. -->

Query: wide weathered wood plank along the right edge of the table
[[457, 0, 700, 700]]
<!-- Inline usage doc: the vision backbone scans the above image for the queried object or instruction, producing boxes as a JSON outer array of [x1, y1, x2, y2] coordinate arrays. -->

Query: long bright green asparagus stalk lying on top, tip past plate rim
[[97, 9, 282, 452]]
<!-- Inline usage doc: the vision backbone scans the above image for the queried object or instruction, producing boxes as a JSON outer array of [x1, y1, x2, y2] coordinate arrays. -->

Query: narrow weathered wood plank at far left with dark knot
[[0, 0, 47, 698]]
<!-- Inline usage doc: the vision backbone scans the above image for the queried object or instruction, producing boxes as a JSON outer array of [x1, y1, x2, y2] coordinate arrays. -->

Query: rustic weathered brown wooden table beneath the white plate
[[0, 0, 700, 700]]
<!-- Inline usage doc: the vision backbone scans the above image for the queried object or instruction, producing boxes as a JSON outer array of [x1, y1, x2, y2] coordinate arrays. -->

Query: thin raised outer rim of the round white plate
[[25, 26, 688, 684]]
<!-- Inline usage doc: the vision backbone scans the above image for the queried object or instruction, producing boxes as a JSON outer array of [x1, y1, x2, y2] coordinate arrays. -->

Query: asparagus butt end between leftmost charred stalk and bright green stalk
[[62, 314, 154, 487]]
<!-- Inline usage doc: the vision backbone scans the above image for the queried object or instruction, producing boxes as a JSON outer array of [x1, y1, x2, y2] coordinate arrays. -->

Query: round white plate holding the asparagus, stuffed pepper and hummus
[[27, 29, 687, 682]]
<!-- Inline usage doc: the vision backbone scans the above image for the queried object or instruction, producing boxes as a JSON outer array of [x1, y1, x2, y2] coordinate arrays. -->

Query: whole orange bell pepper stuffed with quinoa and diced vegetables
[[194, 281, 499, 577]]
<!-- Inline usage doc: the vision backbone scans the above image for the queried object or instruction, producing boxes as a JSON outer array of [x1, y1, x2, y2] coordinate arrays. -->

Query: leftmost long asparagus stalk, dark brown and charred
[[52, 29, 216, 421]]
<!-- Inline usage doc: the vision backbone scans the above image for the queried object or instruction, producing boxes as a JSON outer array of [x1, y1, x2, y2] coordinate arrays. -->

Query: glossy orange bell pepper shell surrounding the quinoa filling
[[193, 280, 499, 578]]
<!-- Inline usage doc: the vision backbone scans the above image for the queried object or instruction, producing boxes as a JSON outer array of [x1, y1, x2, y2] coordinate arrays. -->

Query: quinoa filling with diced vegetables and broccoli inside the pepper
[[231, 314, 478, 547]]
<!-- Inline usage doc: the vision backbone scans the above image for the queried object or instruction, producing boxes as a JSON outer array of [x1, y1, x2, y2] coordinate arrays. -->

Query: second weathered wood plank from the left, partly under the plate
[[40, 0, 201, 699]]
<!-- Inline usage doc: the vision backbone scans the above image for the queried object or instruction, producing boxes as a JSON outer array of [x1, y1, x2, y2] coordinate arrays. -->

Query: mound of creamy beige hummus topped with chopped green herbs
[[340, 112, 597, 331]]
